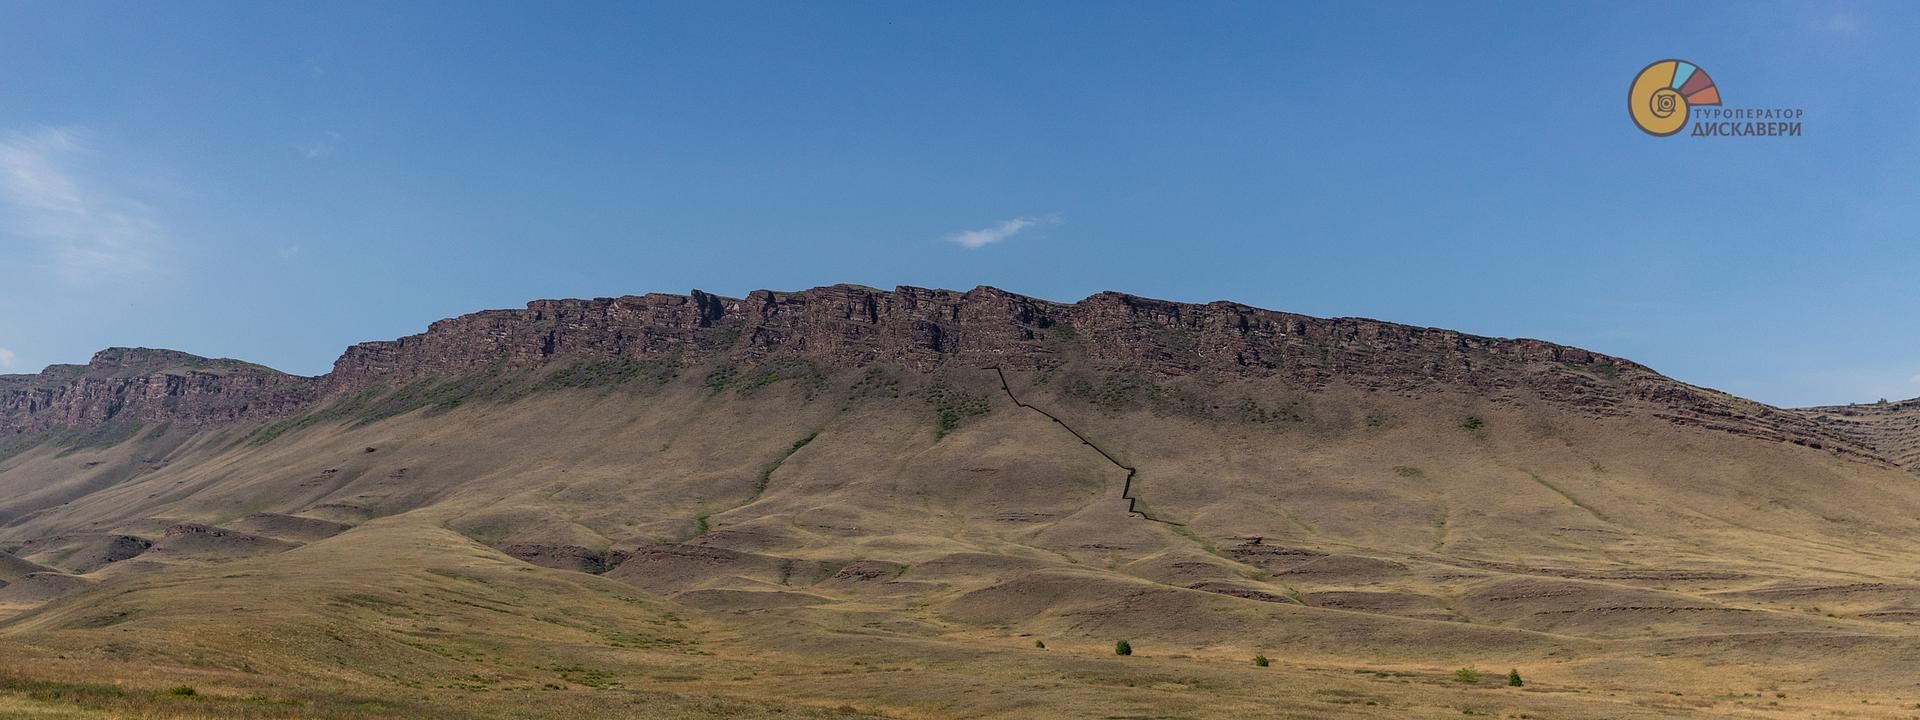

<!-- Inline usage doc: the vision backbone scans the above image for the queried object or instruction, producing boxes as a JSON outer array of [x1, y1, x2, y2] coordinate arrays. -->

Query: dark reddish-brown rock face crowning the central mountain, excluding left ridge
[[311, 286, 1647, 392]]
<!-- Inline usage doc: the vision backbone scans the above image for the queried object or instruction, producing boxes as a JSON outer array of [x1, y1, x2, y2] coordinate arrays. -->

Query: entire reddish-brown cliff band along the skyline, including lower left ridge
[[0, 286, 1868, 464]]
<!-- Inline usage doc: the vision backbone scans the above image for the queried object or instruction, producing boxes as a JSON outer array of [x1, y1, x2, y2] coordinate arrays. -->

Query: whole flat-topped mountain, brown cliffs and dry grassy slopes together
[[0, 286, 1920, 720]]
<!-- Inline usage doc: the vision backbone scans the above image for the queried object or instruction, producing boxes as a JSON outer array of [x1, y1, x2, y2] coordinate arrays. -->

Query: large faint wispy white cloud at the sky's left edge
[[0, 129, 165, 280]]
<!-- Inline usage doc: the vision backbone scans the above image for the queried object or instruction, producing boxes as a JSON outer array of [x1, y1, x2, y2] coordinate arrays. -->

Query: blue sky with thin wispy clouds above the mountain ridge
[[0, 0, 1920, 405]]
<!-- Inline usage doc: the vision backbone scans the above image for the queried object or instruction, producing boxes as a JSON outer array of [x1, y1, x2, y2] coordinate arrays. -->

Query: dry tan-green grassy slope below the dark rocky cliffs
[[0, 362, 1920, 718]]
